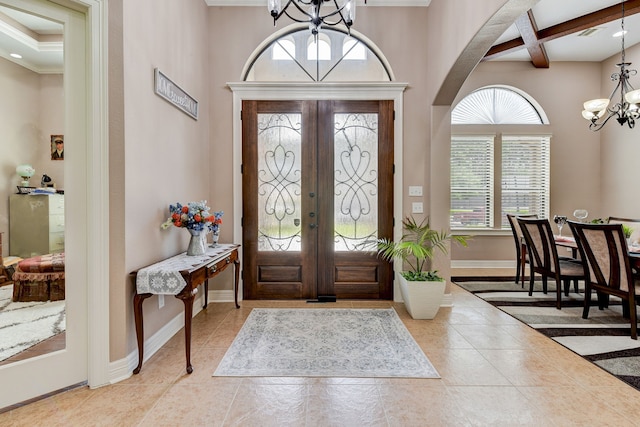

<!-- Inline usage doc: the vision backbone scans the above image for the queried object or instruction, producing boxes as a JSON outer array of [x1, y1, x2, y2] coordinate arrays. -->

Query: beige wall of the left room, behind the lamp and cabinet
[[0, 58, 64, 256]]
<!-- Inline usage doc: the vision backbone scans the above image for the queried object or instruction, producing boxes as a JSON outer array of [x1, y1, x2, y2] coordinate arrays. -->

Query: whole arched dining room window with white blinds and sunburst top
[[450, 86, 551, 229]]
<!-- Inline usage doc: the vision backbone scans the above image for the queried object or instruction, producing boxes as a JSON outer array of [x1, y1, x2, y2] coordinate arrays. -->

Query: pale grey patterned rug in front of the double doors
[[213, 308, 440, 378]]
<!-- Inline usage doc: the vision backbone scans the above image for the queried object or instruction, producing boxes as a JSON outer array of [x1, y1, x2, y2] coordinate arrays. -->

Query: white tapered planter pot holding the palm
[[398, 273, 447, 319]]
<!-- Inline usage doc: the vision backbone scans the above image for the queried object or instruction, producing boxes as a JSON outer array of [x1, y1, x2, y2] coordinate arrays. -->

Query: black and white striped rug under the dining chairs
[[456, 281, 640, 390]]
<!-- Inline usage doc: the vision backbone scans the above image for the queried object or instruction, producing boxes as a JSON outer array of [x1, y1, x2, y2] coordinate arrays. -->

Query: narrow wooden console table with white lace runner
[[131, 244, 240, 374]]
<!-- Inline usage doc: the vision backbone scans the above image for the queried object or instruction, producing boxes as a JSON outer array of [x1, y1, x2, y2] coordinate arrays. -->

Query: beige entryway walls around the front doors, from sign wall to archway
[[109, 0, 576, 360]]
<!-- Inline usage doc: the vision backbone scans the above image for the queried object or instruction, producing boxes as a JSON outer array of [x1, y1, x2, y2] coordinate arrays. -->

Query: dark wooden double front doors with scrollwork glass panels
[[242, 101, 393, 299]]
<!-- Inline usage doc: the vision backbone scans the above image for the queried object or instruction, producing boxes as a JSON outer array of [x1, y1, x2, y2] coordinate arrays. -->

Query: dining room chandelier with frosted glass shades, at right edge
[[582, 0, 640, 131]]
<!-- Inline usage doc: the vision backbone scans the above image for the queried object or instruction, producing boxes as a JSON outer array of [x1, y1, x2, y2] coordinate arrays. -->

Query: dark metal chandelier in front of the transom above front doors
[[267, 0, 367, 35]]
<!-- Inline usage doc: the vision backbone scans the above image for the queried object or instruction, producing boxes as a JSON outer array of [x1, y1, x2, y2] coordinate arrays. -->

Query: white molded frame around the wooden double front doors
[[227, 82, 408, 301]]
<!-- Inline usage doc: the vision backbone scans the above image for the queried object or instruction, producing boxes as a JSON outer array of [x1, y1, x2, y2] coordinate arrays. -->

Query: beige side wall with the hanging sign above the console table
[[110, 0, 211, 359]]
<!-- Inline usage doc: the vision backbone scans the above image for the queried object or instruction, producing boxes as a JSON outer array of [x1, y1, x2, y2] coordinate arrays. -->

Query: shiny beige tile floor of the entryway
[[0, 285, 640, 427]]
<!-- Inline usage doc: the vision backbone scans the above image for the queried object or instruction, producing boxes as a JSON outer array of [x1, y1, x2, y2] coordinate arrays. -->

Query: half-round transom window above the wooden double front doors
[[242, 24, 394, 82]]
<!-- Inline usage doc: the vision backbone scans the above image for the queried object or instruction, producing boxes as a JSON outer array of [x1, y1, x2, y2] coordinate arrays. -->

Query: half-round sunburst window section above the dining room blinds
[[451, 86, 549, 125]]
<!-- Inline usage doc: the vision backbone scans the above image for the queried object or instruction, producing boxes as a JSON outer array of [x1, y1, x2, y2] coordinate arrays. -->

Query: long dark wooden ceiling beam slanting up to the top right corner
[[483, 0, 640, 61]]
